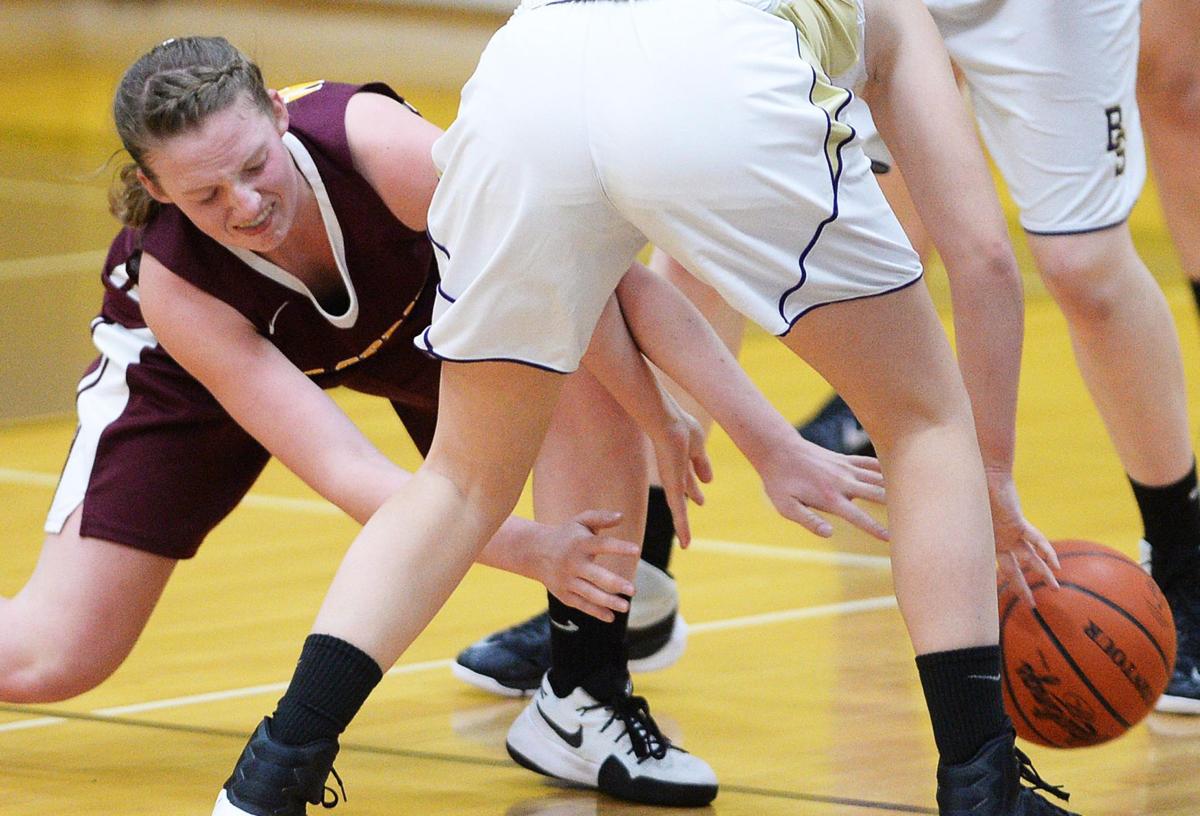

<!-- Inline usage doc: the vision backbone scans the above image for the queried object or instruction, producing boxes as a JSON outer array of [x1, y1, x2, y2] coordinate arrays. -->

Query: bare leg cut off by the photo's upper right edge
[[1138, 0, 1200, 281]]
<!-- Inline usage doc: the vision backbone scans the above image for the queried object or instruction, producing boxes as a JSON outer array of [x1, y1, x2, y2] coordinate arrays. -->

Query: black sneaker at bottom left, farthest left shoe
[[212, 716, 346, 816]]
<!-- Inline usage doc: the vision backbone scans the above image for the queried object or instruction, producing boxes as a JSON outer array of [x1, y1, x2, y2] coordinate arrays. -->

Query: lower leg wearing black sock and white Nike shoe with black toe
[[506, 370, 716, 805]]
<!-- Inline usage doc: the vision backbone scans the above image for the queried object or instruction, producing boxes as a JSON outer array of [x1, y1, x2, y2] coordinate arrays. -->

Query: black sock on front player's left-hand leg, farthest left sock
[[271, 635, 383, 745]]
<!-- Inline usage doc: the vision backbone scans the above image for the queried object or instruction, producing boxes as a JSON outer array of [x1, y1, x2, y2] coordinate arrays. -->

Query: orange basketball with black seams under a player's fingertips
[[1000, 541, 1175, 748]]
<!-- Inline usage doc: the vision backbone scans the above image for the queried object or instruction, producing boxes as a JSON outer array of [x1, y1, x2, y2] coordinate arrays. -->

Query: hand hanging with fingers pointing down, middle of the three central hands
[[650, 391, 713, 547]]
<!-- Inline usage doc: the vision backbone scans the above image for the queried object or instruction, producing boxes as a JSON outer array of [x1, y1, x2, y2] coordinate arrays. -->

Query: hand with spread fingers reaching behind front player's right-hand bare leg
[[756, 433, 888, 541]]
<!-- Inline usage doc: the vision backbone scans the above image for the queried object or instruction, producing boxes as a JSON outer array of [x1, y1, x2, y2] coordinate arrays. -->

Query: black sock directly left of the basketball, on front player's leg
[[917, 646, 1008, 764]]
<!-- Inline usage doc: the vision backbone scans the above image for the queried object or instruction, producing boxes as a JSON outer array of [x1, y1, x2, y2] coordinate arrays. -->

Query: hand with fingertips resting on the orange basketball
[[988, 470, 1061, 606]]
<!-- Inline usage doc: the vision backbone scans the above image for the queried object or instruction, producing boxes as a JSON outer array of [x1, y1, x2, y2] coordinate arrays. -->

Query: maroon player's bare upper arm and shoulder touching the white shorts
[[346, 92, 442, 230]]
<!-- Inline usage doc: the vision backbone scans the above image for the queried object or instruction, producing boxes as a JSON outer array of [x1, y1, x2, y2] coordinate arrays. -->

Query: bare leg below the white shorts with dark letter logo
[[1030, 224, 1192, 485]]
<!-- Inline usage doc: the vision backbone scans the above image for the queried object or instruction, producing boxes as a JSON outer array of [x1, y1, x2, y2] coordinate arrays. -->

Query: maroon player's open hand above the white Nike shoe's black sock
[[536, 510, 642, 622]]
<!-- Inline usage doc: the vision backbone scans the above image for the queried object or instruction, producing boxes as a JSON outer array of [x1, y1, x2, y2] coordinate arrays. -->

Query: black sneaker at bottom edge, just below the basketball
[[937, 728, 1079, 816]]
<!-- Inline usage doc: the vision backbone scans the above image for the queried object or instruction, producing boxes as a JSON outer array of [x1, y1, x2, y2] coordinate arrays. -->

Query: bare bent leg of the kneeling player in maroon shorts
[[0, 510, 176, 703]]
